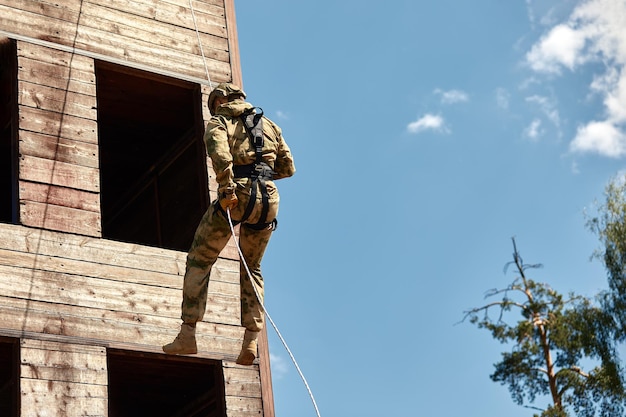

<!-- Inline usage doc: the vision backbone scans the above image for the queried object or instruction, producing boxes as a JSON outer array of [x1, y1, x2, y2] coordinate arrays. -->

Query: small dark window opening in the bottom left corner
[[0, 336, 20, 417]]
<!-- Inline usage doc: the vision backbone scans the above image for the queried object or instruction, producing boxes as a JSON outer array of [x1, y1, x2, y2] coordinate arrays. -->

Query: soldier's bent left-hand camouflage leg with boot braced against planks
[[163, 202, 231, 354]]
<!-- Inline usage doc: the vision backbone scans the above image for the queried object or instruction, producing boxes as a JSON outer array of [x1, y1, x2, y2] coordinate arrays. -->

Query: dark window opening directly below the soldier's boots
[[107, 350, 226, 417]]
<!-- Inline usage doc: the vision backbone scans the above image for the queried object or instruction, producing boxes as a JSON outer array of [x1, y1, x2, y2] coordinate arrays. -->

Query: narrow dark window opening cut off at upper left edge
[[0, 38, 18, 223]]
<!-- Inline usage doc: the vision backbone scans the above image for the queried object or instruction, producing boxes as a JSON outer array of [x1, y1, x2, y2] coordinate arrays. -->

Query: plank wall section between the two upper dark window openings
[[17, 42, 102, 236]]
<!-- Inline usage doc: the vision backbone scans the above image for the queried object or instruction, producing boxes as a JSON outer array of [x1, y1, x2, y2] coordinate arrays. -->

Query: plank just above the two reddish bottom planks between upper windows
[[20, 155, 100, 192]]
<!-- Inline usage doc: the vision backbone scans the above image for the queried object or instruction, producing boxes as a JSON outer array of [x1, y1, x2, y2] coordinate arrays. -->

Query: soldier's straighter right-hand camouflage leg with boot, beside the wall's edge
[[237, 225, 272, 365]]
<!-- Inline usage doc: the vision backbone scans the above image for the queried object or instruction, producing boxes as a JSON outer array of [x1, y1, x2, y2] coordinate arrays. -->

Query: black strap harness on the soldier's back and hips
[[223, 107, 278, 230]]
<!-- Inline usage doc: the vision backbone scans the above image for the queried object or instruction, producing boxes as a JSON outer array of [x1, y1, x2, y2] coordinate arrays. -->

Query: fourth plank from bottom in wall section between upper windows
[[19, 130, 99, 169]]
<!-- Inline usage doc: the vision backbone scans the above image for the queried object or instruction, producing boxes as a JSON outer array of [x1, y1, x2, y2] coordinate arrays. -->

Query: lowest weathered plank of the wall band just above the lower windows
[[0, 295, 243, 355]]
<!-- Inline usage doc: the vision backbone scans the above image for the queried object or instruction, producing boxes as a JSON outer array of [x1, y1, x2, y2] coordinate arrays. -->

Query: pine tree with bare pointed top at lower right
[[465, 240, 626, 417]]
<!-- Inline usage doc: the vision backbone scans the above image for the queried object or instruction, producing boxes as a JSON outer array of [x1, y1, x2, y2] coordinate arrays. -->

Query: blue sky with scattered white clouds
[[236, 0, 626, 417]]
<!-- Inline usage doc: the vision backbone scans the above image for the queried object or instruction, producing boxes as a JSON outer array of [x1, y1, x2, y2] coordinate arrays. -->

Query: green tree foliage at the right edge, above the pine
[[587, 175, 626, 341]]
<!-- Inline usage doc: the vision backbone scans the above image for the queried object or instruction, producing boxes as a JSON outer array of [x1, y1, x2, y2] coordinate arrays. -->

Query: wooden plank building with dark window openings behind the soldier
[[0, 0, 274, 417]]
